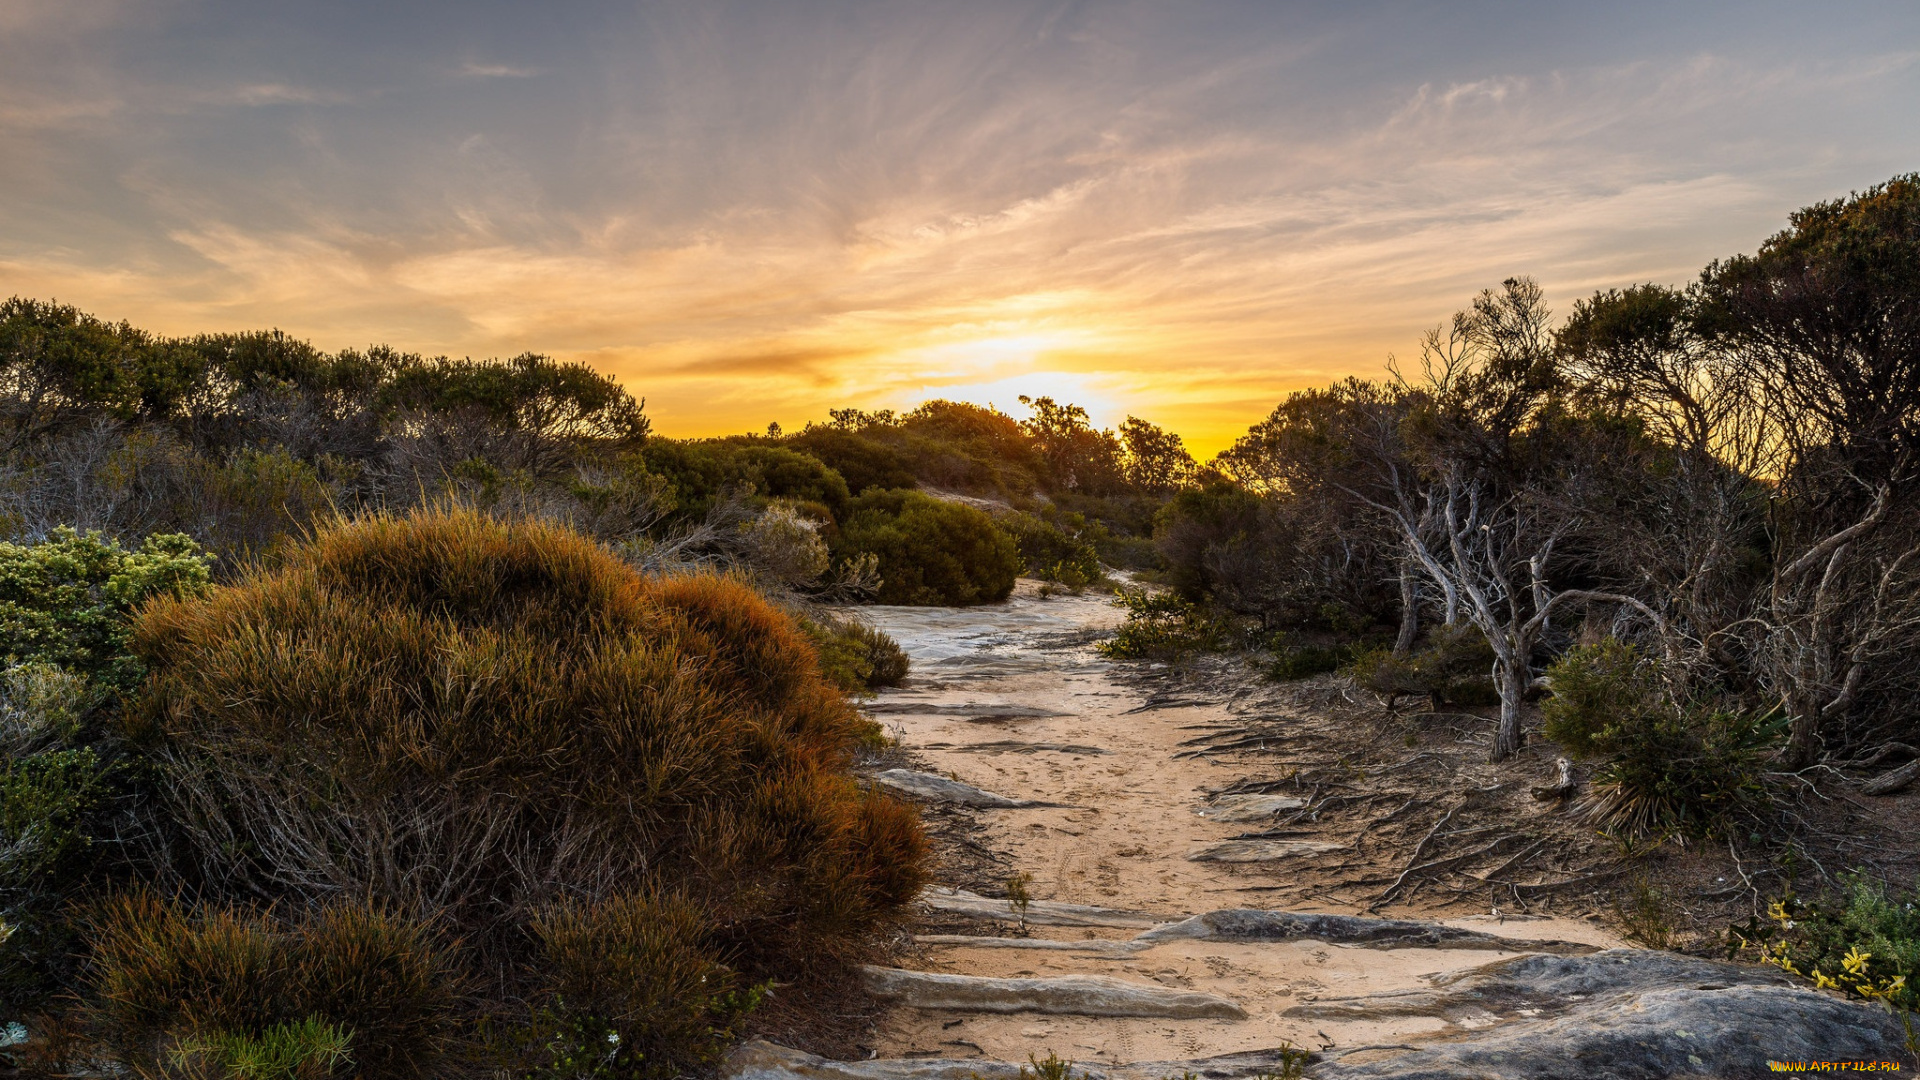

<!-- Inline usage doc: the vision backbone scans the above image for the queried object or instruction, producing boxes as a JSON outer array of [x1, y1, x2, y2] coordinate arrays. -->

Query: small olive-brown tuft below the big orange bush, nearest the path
[[534, 896, 764, 1080]]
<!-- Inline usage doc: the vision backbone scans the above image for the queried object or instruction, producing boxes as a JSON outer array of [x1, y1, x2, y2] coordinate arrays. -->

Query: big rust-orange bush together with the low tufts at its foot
[[6, 509, 925, 1076]]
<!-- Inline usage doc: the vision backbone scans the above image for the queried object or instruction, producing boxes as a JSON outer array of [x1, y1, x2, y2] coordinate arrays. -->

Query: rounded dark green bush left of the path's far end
[[835, 490, 1020, 607]]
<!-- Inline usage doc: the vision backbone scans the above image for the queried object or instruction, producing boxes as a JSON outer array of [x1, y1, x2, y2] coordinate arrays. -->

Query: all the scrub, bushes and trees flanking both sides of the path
[[0, 175, 1920, 1076]]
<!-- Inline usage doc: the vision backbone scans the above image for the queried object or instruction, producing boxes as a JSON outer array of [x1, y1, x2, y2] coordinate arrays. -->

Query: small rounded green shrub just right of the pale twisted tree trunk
[[1540, 638, 1663, 757]]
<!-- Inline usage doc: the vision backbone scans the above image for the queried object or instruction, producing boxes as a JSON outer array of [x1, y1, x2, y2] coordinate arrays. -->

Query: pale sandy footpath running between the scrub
[[860, 582, 1619, 1065]]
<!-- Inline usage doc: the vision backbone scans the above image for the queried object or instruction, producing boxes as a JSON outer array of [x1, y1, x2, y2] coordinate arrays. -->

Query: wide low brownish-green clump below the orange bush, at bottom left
[[90, 896, 463, 1080]]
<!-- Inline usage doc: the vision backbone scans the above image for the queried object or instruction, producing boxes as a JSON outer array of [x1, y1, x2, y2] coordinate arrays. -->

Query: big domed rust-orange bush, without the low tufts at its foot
[[110, 509, 925, 1068]]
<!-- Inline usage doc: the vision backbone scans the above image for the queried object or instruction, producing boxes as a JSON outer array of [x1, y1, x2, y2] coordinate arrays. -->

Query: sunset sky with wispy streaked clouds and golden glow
[[0, 0, 1920, 454]]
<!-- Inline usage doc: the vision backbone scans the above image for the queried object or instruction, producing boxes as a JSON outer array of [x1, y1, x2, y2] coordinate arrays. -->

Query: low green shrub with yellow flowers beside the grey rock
[[1728, 874, 1920, 1013]]
